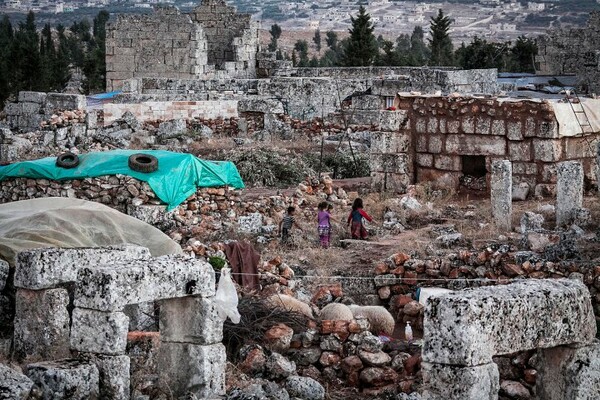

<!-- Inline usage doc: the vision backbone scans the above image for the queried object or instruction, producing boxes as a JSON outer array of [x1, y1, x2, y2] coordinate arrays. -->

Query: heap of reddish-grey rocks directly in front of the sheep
[[238, 318, 420, 398]]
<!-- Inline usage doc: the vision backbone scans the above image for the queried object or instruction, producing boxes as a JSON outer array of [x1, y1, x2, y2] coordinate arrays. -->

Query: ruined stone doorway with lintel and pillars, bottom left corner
[[2, 246, 225, 399]]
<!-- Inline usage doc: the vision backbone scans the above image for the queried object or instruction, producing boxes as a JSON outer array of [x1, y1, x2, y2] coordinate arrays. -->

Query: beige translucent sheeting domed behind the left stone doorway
[[0, 197, 183, 265]]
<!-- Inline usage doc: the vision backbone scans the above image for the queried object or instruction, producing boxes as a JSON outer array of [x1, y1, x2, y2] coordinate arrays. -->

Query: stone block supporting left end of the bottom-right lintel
[[423, 362, 500, 400]]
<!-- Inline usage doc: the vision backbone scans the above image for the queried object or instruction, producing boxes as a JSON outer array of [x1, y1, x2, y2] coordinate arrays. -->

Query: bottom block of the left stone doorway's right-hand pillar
[[158, 342, 226, 399]]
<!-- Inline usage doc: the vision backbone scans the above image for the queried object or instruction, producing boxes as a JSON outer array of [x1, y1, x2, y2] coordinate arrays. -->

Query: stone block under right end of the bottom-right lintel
[[536, 341, 600, 400]]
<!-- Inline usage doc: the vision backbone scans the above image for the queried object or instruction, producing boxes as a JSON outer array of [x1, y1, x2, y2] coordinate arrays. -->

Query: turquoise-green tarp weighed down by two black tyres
[[0, 150, 244, 210]]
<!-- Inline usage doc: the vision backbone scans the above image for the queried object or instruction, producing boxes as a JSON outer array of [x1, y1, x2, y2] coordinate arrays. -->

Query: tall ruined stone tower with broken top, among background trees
[[106, 0, 259, 91]]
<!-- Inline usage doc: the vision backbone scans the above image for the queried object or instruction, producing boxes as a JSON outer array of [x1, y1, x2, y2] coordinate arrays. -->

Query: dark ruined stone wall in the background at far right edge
[[536, 11, 600, 94]]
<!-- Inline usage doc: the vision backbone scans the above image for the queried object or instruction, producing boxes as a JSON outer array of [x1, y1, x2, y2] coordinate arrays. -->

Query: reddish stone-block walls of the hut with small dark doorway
[[372, 96, 598, 195]]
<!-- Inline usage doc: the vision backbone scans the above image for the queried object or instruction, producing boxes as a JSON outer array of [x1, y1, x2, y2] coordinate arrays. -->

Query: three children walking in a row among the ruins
[[279, 198, 373, 248]]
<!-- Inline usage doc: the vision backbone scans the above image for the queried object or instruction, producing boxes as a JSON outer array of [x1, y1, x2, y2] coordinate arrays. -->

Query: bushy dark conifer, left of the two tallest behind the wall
[[343, 6, 378, 67]]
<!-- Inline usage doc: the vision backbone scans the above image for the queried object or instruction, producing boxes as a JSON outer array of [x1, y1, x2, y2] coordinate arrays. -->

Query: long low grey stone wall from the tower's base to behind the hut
[[110, 67, 498, 120]]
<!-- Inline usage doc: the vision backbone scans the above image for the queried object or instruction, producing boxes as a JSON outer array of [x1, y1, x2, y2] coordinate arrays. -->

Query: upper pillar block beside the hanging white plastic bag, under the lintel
[[160, 296, 223, 345]]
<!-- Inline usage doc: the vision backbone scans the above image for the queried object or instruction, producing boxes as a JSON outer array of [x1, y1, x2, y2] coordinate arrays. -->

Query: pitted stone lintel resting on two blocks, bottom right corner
[[423, 280, 600, 400]]
